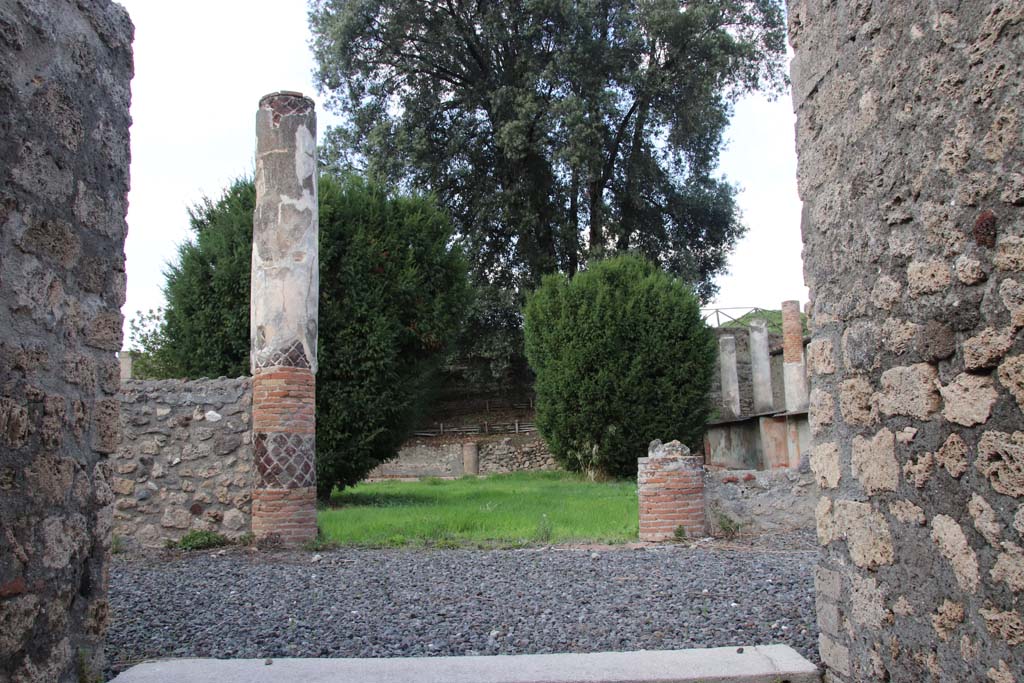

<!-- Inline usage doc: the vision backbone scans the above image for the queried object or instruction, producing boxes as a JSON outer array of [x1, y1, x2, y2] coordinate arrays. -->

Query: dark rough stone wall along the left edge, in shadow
[[0, 0, 132, 682]]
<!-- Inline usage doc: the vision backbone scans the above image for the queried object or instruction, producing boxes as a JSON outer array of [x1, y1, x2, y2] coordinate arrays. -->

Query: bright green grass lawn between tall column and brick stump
[[317, 472, 637, 547]]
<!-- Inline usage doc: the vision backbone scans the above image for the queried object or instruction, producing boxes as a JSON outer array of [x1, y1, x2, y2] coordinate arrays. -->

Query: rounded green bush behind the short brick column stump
[[525, 255, 715, 476]]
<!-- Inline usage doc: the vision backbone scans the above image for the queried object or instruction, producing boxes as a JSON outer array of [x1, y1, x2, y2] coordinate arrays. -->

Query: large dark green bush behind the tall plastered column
[[132, 176, 469, 497]]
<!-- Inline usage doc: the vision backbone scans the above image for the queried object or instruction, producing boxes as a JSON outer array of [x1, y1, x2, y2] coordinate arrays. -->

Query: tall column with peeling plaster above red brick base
[[250, 92, 319, 545]]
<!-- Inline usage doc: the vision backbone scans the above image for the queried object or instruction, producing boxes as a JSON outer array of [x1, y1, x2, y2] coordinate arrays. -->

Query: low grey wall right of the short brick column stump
[[705, 468, 819, 536]]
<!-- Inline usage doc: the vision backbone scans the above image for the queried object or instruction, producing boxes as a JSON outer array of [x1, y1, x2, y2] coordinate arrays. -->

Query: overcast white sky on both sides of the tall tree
[[119, 0, 807, 343]]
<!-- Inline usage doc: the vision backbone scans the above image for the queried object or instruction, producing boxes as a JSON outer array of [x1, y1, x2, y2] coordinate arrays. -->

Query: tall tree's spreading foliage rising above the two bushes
[[310, 0, 784, 298]]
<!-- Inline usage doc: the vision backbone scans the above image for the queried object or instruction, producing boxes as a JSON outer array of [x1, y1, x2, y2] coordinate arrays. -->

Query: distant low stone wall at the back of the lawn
[[367, 434, 558, 481]]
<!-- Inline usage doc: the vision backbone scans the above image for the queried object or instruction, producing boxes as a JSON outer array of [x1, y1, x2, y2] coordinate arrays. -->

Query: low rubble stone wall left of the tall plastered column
[[111, 378, 254, 547]]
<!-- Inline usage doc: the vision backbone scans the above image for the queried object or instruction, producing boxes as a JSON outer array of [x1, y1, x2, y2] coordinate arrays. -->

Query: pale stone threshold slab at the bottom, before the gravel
[[114, 645, 821, 683]]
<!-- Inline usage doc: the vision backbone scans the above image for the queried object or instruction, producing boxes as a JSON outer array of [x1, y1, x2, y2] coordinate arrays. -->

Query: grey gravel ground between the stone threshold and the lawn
[[106, 532, 818, 675]]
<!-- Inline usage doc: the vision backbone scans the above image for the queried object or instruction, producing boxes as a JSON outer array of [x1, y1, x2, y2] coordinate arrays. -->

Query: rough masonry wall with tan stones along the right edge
[[788, 0, 1024, 683]]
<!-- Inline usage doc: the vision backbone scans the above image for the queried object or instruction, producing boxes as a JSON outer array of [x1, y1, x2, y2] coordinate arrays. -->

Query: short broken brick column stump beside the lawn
[[637, 441, 706, 541]]
